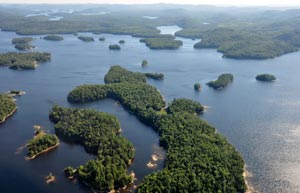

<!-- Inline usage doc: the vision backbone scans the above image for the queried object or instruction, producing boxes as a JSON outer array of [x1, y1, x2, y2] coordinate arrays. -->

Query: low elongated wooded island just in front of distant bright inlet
[[140, 38, 183, 50]]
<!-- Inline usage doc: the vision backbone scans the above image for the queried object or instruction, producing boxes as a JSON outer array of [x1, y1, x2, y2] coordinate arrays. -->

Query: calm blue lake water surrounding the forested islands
[[0, 28, 300, 193]]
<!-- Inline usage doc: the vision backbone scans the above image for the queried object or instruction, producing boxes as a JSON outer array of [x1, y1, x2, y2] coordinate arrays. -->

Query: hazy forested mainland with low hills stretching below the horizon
[[0, 5, 300, 59]]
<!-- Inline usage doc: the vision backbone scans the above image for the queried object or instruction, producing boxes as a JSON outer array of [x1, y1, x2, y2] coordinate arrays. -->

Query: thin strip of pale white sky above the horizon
[[0, 0, 300, 6]]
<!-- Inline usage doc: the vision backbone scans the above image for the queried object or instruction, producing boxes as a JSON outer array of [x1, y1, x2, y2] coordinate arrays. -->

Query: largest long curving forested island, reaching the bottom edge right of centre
[[66, 67, 246, 193]]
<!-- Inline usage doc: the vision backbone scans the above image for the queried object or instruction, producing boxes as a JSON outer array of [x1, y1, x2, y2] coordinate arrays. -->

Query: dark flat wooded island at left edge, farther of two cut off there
[[0, 52, 51, 70]]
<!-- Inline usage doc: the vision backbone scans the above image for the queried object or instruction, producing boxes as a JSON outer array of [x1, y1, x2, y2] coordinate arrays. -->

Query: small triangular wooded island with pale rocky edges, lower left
[[26, 126, 59, 160]]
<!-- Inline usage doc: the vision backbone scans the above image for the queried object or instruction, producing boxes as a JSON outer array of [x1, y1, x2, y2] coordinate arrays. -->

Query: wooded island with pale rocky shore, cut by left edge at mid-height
[[0, 94, 17, 124]]
